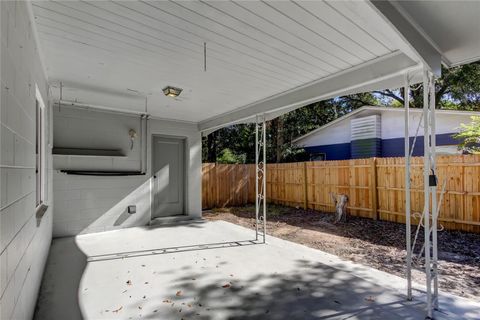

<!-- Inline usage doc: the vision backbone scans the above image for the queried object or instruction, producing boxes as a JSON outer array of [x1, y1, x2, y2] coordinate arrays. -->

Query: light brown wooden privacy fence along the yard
[[202, 155, 480, 233]]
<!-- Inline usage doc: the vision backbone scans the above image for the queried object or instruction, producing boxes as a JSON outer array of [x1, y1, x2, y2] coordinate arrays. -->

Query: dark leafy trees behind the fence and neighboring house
[[203, 62, 480, 163]]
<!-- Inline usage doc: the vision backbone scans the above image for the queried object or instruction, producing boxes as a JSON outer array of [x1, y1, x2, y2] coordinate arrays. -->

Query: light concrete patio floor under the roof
[[35, 221, 480, 320]]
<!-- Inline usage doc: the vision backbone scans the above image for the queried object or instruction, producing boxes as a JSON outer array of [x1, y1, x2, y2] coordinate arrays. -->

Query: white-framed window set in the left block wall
[[35, 91, 45, 207]]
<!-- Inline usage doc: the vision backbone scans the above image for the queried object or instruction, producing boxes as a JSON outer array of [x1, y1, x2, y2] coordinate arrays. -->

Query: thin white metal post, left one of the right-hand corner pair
[[403, 74, 412, 300]]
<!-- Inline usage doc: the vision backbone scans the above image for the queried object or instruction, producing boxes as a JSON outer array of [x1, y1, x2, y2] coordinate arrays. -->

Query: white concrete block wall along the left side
[[0, 1, 53, 320]]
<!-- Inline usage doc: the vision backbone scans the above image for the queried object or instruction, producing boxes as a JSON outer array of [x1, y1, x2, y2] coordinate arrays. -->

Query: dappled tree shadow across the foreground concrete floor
[[133, 260, 440, 320]]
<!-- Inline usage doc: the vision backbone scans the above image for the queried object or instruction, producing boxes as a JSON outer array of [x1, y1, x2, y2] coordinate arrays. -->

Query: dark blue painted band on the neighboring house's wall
[[305, 133, 459, 160]]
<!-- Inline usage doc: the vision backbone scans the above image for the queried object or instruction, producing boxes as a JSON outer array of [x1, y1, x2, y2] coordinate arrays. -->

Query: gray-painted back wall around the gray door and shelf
[[53, 106, 201, 237]]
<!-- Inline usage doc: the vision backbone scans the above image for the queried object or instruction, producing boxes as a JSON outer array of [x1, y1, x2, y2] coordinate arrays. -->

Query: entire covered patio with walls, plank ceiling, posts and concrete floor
[[0, 1, 480, 320]]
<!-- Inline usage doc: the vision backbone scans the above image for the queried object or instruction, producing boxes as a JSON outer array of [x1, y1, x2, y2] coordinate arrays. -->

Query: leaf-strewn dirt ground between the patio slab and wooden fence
[[204, 206, 480, 300]]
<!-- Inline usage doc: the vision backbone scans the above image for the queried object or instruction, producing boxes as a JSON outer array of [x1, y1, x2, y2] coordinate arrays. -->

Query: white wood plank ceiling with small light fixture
[[33, 1, 411, 122]]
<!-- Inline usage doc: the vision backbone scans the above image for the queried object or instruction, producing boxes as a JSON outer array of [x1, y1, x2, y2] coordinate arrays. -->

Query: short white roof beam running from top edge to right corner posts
[[370, 0, 442, 77]]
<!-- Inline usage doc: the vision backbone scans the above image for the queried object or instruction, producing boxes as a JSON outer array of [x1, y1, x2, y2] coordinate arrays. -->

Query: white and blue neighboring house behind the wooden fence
[[293, 106, 480, 160]]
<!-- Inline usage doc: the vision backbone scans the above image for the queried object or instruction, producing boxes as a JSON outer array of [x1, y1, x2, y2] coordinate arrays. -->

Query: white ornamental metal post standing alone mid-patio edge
[[255, 115, 267, 243]]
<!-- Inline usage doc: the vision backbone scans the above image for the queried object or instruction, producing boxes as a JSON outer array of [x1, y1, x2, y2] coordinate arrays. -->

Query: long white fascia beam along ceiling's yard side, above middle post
[[198, 51, 419, 131]]
